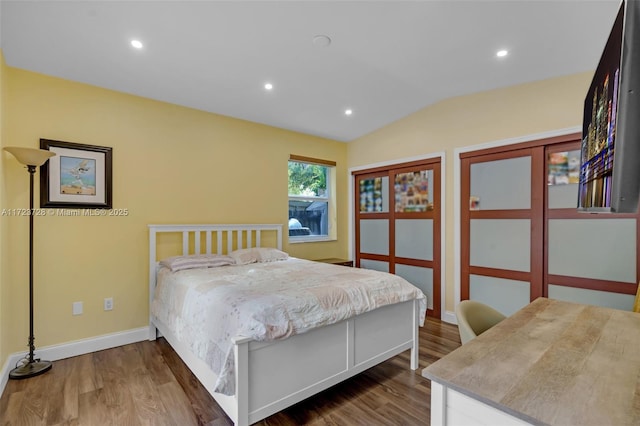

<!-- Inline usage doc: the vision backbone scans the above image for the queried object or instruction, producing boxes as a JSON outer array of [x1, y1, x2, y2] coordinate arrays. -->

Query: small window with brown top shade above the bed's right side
[[289, 155, 336, 241]]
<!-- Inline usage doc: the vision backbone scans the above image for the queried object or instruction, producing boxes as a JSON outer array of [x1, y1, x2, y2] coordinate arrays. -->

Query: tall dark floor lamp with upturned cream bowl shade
[[5, 147, 55, 379]]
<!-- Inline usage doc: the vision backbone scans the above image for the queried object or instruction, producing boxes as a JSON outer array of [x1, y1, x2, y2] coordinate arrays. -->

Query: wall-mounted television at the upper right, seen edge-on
[[578, 0, 640, 213]]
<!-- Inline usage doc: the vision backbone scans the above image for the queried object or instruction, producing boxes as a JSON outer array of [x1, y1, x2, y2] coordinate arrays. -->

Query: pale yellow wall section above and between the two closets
[[348, 72, 593, 311]]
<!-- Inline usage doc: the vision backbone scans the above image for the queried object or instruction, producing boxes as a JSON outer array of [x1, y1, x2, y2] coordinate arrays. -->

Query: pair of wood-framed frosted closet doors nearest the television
[[460, 134, 640, 315]]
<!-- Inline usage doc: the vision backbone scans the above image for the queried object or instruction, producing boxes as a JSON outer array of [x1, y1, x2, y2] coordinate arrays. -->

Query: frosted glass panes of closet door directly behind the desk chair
[[469, 156, 531, 315]]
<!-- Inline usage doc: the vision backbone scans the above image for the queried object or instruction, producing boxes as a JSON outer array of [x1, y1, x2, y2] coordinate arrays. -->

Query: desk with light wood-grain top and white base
[[422, 298, 640, 426]]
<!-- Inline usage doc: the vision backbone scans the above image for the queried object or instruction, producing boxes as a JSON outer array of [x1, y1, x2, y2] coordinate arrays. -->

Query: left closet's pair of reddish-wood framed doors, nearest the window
[[354, 159, 441, 318]]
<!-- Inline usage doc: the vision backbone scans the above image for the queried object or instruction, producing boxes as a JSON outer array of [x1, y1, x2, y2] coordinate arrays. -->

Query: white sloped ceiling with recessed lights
[[0, 0, 619, 141]]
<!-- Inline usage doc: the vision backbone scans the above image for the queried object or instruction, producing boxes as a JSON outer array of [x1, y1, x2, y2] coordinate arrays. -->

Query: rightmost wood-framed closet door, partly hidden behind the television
[[544, 141, 638, 310]]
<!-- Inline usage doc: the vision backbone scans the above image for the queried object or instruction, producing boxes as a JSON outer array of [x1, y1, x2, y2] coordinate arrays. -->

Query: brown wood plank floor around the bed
[[0, 318, 460, 426]]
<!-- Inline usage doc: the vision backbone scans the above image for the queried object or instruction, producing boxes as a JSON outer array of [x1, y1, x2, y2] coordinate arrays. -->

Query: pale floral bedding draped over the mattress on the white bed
[[151, 258, 426, 395]]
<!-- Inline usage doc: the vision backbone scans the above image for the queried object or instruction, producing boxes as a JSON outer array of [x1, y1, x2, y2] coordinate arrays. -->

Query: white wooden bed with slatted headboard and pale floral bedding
[[149, 224, 426, 425]]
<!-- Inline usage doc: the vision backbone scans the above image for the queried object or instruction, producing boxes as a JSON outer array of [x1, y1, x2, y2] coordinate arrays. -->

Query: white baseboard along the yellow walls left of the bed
[[0, 327, 149, 397]]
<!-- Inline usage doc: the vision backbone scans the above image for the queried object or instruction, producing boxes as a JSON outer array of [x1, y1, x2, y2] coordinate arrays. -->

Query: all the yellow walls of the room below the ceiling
[[0, 62, 591, 358]]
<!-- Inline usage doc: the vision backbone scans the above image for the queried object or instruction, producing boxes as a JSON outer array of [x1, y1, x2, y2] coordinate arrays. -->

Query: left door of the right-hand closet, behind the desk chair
[[461, 148, 544, 315]]
